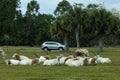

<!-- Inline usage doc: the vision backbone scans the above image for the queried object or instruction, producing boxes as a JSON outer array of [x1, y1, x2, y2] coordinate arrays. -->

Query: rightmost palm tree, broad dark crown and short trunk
[[88, 5, 119, 52]]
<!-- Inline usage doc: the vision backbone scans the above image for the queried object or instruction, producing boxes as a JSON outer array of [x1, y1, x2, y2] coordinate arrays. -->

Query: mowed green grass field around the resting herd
[[0, 46, 120, 80]]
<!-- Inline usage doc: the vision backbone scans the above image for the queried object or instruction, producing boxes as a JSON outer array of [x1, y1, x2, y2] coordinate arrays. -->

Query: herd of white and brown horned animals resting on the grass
[[0, 48, 111, 67]]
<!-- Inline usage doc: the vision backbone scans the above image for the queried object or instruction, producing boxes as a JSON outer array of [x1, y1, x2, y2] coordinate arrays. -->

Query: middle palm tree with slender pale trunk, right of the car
[[69, 4, 86, 49]]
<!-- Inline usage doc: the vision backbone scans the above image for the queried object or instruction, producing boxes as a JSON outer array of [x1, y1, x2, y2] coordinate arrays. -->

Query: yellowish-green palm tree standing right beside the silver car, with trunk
[[50, 15, 70, 51]]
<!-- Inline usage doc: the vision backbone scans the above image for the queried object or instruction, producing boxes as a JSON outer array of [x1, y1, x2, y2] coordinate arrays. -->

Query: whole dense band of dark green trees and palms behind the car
[[0, 0, 120, 51]]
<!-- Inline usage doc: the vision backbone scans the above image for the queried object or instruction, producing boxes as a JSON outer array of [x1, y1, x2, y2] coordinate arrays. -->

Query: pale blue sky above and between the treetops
[[20, 0, 120, 14]]
